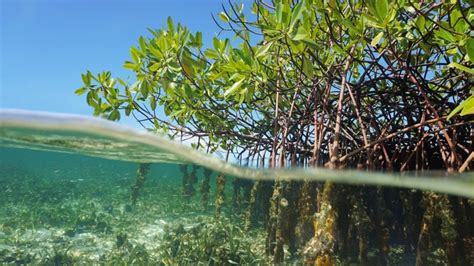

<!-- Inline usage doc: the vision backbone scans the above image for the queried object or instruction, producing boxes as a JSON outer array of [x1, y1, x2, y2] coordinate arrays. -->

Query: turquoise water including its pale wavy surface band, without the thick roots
[[0, 111, 474, 264]]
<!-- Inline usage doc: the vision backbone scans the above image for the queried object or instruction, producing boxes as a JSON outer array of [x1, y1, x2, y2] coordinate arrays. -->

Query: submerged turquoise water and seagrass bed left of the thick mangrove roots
[[0, 148, 265, 265]]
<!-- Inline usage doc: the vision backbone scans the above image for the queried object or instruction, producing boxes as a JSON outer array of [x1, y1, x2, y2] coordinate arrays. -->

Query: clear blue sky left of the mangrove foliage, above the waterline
[[0, 0, 250, 125]]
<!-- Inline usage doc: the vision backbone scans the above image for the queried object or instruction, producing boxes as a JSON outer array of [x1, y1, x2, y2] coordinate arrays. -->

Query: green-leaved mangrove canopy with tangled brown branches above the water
[[76, 0, 474, 168]]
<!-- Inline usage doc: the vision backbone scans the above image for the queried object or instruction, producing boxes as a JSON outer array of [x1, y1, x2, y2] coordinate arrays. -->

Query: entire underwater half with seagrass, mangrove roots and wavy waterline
[[0, 111, 474, 265]]
